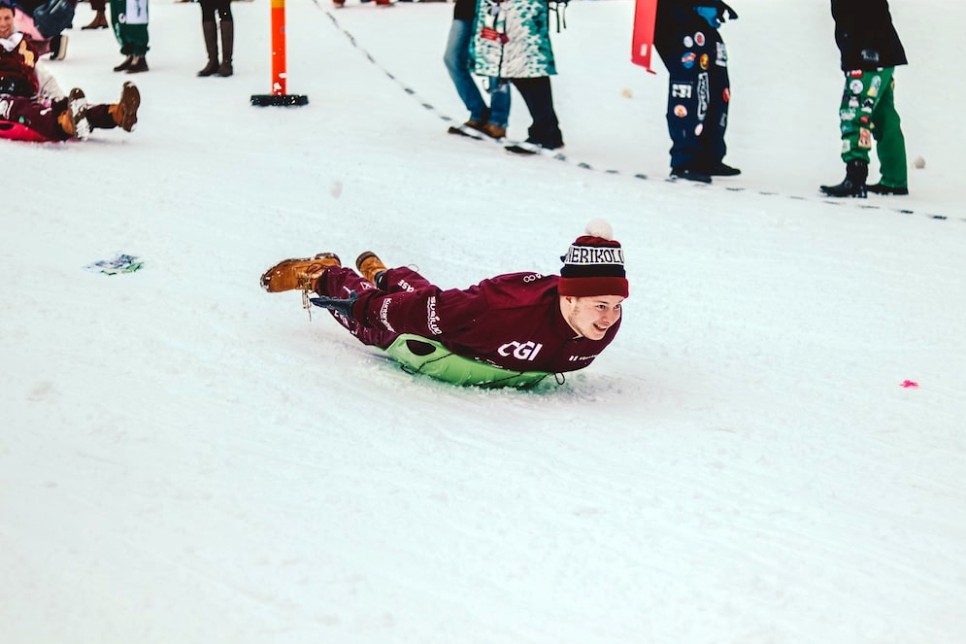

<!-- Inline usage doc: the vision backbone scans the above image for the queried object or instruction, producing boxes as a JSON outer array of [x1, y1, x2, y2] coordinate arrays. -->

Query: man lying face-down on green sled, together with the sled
[[261, 220, 628, 388]]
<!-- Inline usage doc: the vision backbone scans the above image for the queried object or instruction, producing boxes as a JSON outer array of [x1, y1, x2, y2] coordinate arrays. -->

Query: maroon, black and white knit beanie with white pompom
[[557, 219, 628, 297]]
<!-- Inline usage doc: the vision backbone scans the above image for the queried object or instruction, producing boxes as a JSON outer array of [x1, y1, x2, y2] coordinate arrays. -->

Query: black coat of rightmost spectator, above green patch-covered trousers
[[832, 0, 908, 71]]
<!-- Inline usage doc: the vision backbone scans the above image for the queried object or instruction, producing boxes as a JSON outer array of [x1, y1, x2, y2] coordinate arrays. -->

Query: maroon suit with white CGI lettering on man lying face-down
[[317, 268, 620, 373]]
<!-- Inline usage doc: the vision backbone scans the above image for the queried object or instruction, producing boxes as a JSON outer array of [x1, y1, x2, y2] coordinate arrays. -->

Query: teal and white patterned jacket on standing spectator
[[470, 0, 557, 78]]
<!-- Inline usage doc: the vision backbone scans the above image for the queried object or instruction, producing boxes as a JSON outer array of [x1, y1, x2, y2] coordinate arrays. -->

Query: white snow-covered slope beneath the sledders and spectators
[[0, 0, 966, 644]]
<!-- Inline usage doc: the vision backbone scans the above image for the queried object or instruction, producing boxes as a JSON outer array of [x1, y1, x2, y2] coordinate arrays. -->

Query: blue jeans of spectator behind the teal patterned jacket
[[443, 20, 510, 127]]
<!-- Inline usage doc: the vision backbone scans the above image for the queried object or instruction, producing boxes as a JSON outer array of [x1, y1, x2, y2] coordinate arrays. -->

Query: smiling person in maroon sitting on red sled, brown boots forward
[[0, 0, 141, 141]]
